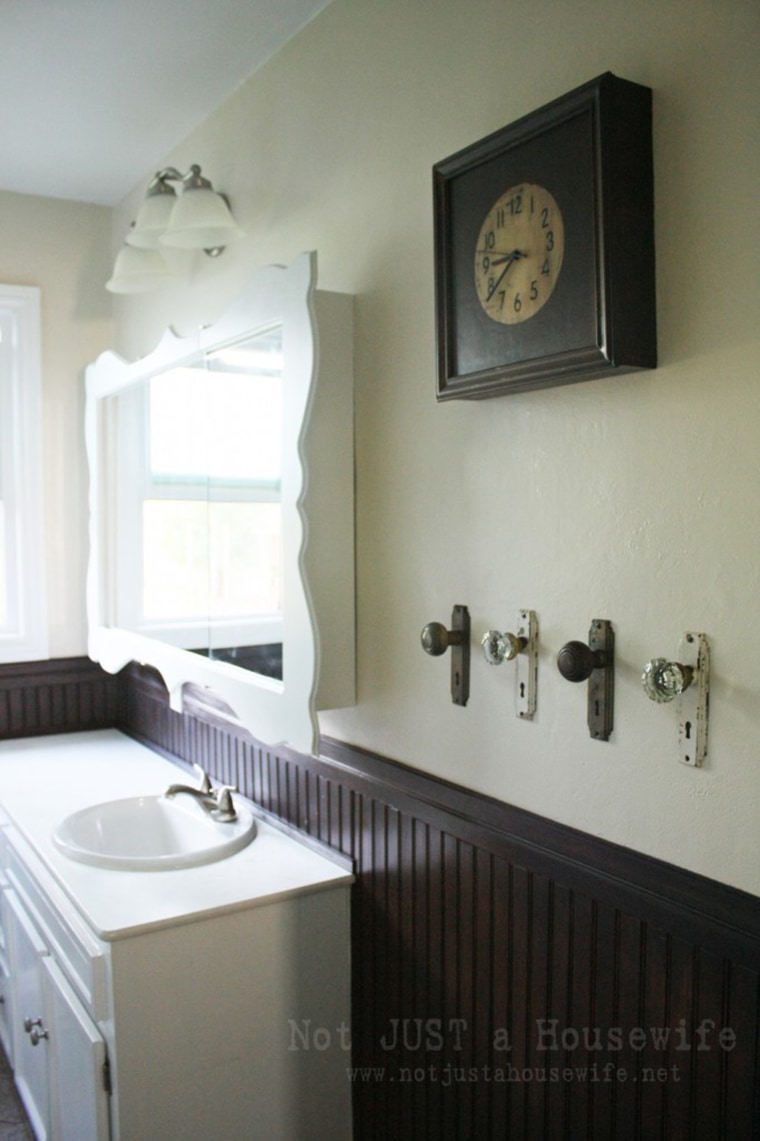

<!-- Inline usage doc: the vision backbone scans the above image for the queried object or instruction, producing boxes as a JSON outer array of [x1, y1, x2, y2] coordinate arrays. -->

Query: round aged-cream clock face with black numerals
[[475, 183, 565, 325]]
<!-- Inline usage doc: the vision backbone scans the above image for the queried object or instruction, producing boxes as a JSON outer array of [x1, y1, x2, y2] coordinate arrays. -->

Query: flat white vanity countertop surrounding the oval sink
[[0, 729, 353, 940]]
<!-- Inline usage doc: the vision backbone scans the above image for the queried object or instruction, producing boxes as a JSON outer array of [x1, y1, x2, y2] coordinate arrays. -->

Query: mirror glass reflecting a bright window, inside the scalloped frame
[[111, 326, 283, 679]]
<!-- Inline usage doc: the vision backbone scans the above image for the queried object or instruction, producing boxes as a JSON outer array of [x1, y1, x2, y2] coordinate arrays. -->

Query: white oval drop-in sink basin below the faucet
[[52, 795, 256, 872]]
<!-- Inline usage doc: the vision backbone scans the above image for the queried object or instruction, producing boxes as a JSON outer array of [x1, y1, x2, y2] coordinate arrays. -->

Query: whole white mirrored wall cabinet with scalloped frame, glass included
[[86, 253, 355, 752]]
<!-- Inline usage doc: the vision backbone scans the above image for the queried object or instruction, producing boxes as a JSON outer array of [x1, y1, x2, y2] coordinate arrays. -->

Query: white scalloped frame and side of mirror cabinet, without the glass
[[84, 253, 355, 753]]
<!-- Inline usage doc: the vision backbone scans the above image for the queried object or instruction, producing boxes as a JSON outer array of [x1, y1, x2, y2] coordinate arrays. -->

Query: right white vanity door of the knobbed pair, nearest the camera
[[42, 957, 110, 1141]]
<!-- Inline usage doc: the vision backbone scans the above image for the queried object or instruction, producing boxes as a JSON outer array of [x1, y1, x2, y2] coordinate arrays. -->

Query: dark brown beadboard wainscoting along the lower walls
[[0, 663, 760, 1141]]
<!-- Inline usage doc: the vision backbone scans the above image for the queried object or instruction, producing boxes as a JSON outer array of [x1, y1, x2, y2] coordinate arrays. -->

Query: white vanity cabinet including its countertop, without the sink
[[0, 730, 353, 1141]]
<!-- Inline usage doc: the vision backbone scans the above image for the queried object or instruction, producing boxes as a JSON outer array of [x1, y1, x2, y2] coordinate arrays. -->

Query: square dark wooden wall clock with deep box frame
[[434, 73, 657, 400]]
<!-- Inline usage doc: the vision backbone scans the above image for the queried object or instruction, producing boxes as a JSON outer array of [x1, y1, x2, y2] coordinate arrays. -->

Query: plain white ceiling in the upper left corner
[[0, 0, 330, 205]]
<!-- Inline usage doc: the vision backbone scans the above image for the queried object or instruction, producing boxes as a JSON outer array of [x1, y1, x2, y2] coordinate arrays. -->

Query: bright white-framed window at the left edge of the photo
[[0, 285, 48, 662]]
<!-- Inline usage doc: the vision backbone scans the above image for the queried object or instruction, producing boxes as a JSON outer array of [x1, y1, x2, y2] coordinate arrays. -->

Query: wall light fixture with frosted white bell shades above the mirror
[[106, 163, 244, 293]]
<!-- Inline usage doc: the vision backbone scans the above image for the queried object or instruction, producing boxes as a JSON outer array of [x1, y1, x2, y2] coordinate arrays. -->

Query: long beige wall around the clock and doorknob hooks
[[103, 0, 760, 893]]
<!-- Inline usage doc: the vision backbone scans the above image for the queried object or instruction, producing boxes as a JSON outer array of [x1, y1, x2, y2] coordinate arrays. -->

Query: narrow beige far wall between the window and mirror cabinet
[[0, 193, 113, 657]]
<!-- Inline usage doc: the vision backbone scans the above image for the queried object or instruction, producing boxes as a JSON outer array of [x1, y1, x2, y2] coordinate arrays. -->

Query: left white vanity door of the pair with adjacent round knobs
[[5, 891, 50, 1141]]
